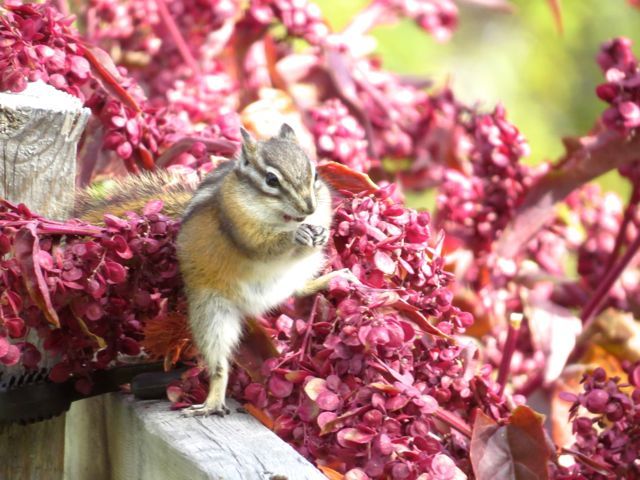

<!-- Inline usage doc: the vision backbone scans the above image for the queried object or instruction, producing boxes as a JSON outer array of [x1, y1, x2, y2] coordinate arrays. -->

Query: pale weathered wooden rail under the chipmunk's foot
[[66, 394, 326, 480]]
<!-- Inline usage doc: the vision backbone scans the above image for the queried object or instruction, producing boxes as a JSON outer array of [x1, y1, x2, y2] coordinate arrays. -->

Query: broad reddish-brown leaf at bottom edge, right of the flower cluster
[[470, 406, 550, 480]]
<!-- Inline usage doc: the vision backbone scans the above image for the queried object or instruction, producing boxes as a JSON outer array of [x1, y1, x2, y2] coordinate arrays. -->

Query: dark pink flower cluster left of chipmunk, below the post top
[[0, 201, 184, 394]]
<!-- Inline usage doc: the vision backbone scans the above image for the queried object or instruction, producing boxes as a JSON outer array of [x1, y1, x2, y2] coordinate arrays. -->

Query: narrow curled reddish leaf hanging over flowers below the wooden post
[[13, 223, 60, 327]]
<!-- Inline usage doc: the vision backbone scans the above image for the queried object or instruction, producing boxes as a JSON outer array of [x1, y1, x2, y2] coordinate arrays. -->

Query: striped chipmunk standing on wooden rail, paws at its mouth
[[79, 124, 358, 416]]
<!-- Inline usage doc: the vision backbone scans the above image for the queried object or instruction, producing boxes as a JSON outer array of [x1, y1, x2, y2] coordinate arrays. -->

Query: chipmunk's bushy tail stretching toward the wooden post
[[74, 169, 198, 225]]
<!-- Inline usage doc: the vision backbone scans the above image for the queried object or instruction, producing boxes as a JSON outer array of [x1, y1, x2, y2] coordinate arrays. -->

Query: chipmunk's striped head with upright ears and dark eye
[[236, 123, 328, 230]]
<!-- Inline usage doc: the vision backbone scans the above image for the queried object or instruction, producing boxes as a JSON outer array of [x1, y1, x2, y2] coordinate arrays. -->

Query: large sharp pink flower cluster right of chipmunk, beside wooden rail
[[170, 187, 507, 479]]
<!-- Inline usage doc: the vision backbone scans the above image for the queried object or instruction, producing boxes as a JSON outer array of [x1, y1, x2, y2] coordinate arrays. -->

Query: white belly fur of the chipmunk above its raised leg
[[238, 252, 325, 316]]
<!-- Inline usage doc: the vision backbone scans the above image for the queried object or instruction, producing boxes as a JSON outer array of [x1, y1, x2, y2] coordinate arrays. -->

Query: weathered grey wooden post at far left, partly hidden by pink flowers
[[0, 82, 91, 480]]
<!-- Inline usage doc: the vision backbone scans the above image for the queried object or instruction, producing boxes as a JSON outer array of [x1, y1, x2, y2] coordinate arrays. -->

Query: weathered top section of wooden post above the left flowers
[[0, 82, 91, 219]]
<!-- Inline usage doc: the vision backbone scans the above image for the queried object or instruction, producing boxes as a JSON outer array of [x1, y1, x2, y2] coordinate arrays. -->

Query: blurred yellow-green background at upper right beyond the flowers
[[315, 0, 640, 194]]
